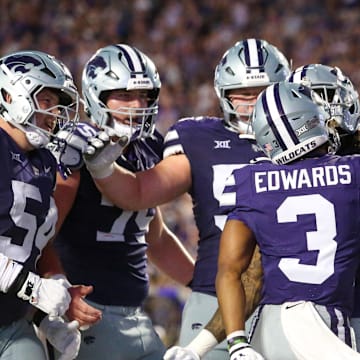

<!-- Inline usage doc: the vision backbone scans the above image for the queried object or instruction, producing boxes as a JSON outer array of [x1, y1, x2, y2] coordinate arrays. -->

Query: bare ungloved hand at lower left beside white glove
[[66, 285, 102, 330]]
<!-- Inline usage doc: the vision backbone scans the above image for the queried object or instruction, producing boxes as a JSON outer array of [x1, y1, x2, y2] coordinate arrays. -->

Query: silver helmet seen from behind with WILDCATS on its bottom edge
[[252, 82, 339, 164]]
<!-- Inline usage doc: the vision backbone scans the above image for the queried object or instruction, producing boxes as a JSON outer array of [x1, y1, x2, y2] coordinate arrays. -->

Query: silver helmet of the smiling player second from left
[[82, 44, 161, 139]]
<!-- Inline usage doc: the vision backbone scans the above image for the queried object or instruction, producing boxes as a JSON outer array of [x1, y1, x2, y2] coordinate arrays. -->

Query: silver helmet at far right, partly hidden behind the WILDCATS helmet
[[288, 64, 360, 134]]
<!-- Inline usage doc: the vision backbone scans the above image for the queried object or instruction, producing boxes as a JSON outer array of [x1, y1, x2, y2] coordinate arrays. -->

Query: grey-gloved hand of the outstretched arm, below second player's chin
[[84, 135, 129, 179]]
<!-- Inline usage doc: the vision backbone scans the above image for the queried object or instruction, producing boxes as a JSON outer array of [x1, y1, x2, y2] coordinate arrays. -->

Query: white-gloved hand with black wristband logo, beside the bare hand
[[17, 271, 71, 316]]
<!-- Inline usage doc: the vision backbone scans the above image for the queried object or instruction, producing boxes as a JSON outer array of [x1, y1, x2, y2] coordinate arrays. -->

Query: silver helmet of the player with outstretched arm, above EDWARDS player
[[214, 39, 290, 133]]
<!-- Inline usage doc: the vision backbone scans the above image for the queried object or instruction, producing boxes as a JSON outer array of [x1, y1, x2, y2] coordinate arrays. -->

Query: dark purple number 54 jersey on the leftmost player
[[0, 129, 57, 326]]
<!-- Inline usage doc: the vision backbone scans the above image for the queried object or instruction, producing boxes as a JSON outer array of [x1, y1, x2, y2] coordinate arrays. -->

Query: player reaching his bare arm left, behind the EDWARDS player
[[83, 39, 290, 360]]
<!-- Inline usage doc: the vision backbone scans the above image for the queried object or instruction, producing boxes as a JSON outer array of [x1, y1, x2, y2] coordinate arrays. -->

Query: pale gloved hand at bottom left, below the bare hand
[[39, 316, 81, 360]]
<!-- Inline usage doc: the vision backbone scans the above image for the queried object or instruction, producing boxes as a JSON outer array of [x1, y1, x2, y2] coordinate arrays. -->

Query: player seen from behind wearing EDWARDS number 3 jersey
[[216, 82, 360, 360]]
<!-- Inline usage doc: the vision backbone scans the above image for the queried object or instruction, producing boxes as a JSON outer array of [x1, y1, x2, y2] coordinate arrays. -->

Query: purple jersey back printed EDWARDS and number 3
[[228, 155, 360, 315]]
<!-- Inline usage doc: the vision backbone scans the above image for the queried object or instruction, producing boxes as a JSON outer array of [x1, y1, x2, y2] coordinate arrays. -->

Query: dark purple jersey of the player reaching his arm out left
[[164, 117, 264, 295]]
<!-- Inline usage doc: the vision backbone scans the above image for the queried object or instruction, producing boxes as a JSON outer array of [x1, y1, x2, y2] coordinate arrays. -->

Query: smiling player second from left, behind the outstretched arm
[[50, 44, 194, 360]]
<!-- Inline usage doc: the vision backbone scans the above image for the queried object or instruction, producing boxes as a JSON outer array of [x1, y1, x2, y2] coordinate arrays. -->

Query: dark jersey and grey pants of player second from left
[[55, 132, 165, 360]]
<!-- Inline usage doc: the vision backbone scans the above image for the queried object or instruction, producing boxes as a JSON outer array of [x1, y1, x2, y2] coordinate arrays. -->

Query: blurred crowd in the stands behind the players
[[0, 0, 360, 345]]
